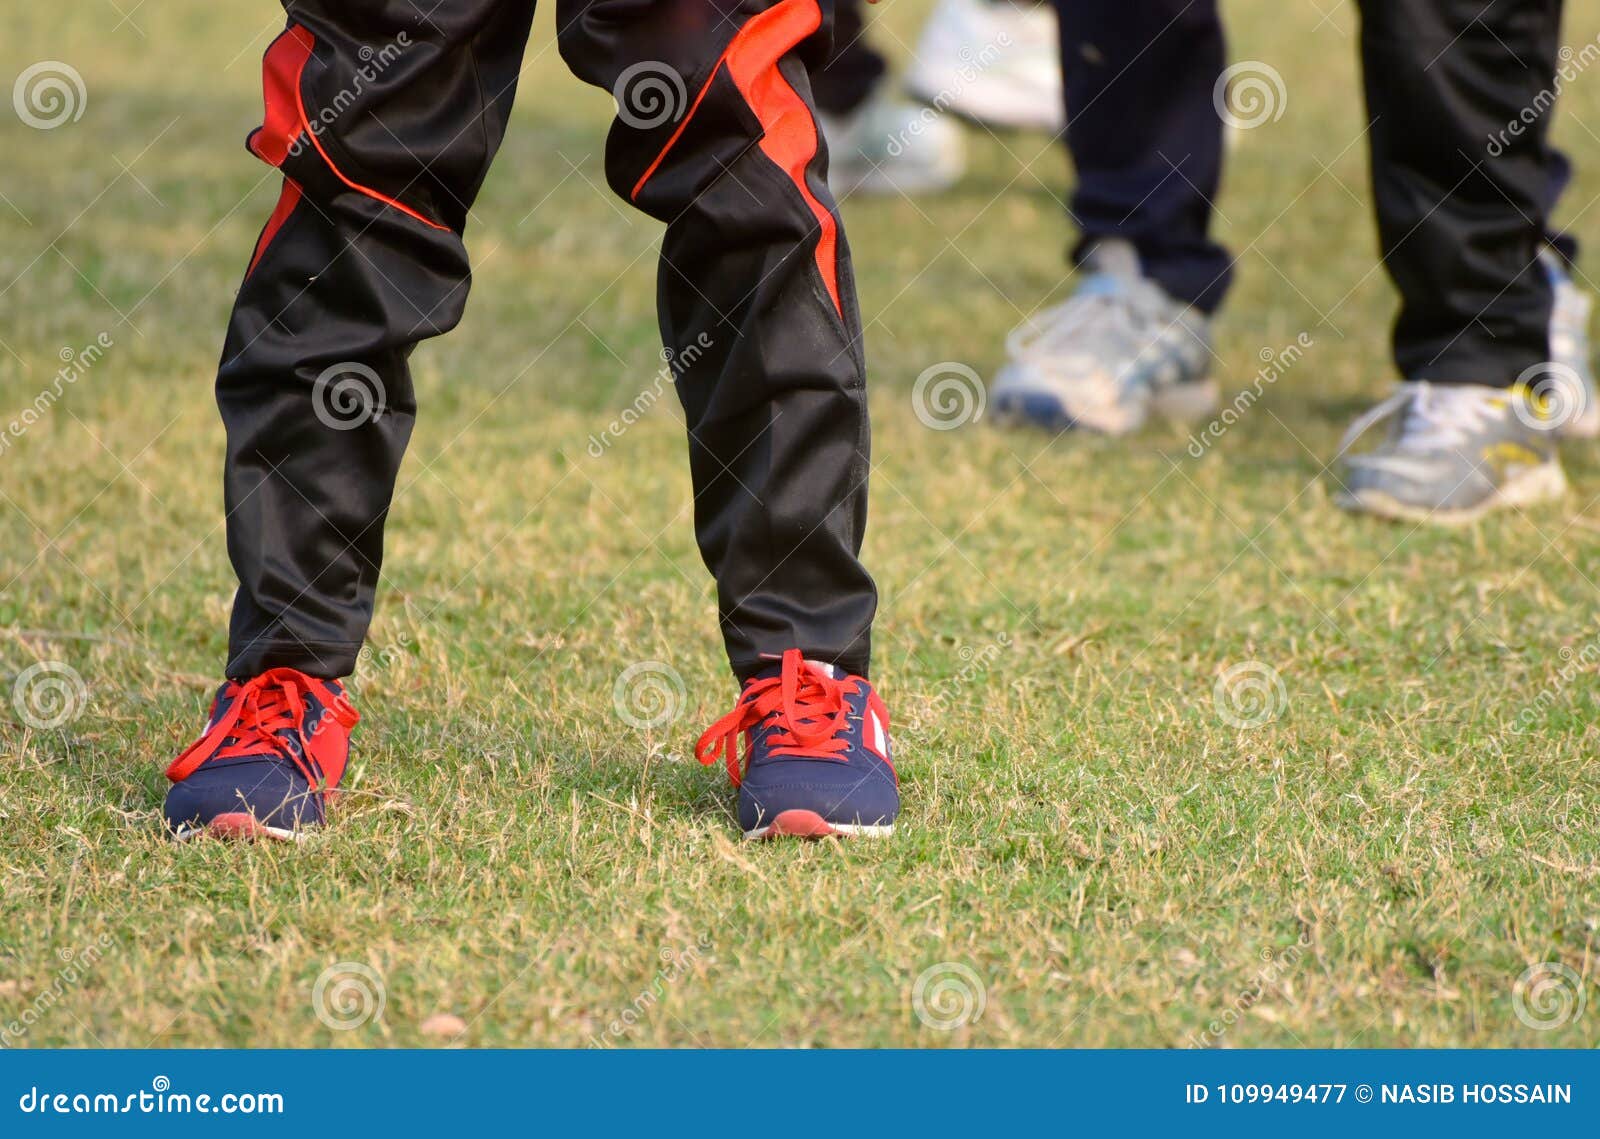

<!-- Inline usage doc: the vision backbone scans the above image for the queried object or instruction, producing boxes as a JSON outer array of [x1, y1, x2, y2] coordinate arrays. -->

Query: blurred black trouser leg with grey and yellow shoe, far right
[[1338, 0, 1594, 523]]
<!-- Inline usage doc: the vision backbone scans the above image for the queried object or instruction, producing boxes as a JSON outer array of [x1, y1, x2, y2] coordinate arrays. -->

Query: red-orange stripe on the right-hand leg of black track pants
[[630, 0, 845, 317]]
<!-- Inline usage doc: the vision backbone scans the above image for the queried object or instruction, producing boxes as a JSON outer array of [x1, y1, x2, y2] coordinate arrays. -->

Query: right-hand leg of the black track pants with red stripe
[[557, 0, 877, 677]]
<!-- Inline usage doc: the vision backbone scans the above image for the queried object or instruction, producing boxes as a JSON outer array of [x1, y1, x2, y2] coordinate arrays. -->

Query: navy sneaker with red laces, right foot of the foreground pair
[[694, 648, 899, 838]]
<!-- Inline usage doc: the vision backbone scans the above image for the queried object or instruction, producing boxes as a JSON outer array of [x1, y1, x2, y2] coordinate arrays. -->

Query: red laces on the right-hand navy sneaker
[[694, 648, 856, 787]]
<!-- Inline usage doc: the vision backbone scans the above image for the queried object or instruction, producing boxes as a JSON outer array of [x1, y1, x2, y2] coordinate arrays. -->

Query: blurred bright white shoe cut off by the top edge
[[906, 0, 1066, 134]]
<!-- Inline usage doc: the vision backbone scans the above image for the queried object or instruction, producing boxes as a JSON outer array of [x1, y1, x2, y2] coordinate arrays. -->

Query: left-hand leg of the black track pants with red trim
[[218, 0, 533, 678]]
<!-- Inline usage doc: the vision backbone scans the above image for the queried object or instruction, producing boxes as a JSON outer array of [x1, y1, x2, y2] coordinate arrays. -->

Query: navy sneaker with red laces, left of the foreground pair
[[165, 669, 360, 840]]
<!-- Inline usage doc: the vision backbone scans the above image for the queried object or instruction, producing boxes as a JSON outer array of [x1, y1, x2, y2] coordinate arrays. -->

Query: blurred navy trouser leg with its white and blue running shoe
[[992, 0, 1232, 435]]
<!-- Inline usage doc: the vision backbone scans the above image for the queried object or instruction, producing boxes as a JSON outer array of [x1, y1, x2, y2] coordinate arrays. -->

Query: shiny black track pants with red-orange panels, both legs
[[218, 0, 875, 677]]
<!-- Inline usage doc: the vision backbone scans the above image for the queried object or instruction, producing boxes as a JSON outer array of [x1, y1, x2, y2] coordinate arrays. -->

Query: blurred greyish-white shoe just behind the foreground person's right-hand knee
[[818, 93, 966, 198]]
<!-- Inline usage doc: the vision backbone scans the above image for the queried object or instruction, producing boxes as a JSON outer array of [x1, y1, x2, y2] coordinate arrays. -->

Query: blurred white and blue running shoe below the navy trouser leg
[[990, 240, 1218, 435]]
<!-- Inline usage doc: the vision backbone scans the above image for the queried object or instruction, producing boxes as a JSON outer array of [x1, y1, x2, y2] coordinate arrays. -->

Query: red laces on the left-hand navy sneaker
[[166, 669, 362, 787]]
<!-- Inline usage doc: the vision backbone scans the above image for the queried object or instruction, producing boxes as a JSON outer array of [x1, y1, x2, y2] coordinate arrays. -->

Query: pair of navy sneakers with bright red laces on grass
[[163, 649, 899, 840]]
